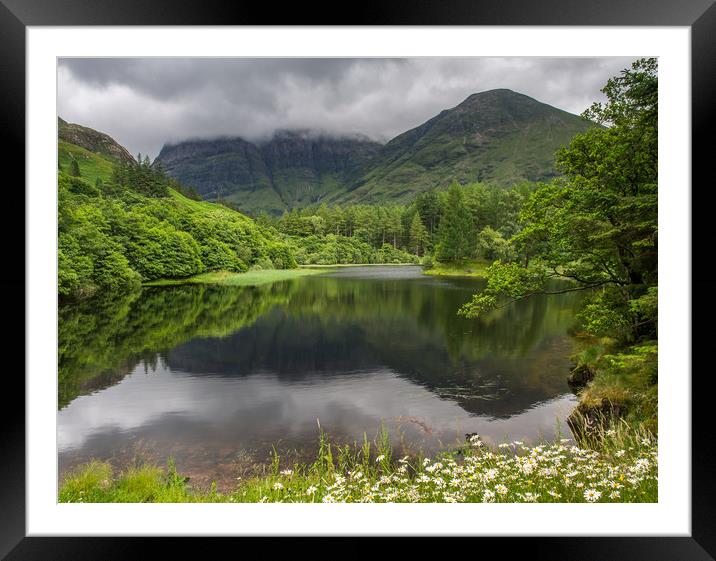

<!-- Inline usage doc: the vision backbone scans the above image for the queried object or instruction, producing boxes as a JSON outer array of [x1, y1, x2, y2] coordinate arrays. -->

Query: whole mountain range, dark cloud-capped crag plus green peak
[[156, 89, 595, 213]]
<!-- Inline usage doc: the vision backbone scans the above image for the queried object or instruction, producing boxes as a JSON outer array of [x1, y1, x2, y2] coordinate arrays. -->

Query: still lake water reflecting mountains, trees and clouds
[[57, 267, 580, 486]]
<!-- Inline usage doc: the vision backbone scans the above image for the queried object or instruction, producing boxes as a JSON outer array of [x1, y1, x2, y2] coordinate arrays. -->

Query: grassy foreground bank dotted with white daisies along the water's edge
[[59, 424, 658, 503]]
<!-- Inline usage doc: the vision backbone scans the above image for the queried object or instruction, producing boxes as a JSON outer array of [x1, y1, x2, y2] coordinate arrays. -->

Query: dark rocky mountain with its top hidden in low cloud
[[155, 131, 381, 213]]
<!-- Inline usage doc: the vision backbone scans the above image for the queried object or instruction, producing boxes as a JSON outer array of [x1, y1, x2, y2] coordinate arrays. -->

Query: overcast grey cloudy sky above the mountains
[[57, 57, 632, 158]]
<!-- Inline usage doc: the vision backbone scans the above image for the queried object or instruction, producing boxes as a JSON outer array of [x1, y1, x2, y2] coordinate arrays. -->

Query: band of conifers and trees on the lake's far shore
[[261, 183, 534, 265]]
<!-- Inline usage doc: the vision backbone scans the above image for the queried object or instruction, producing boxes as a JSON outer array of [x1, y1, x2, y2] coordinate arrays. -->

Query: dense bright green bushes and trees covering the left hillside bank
[[58, 145, 296, 298]]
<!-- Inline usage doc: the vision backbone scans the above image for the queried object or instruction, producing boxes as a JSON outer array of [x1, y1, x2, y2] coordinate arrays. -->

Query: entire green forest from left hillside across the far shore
[[58, 142, 538, 299]]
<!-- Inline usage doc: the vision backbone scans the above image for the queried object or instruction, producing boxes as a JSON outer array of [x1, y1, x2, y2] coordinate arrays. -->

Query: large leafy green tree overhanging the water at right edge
[[463, 59, 658, 341]]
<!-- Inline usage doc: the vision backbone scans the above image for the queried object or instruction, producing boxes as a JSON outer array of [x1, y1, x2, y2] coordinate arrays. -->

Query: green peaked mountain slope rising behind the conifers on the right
[[335, 89, 591, 203]]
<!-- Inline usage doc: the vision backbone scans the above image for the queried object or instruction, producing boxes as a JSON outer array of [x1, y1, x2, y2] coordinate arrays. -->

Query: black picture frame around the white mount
[[0, 0, 716, 561]]
